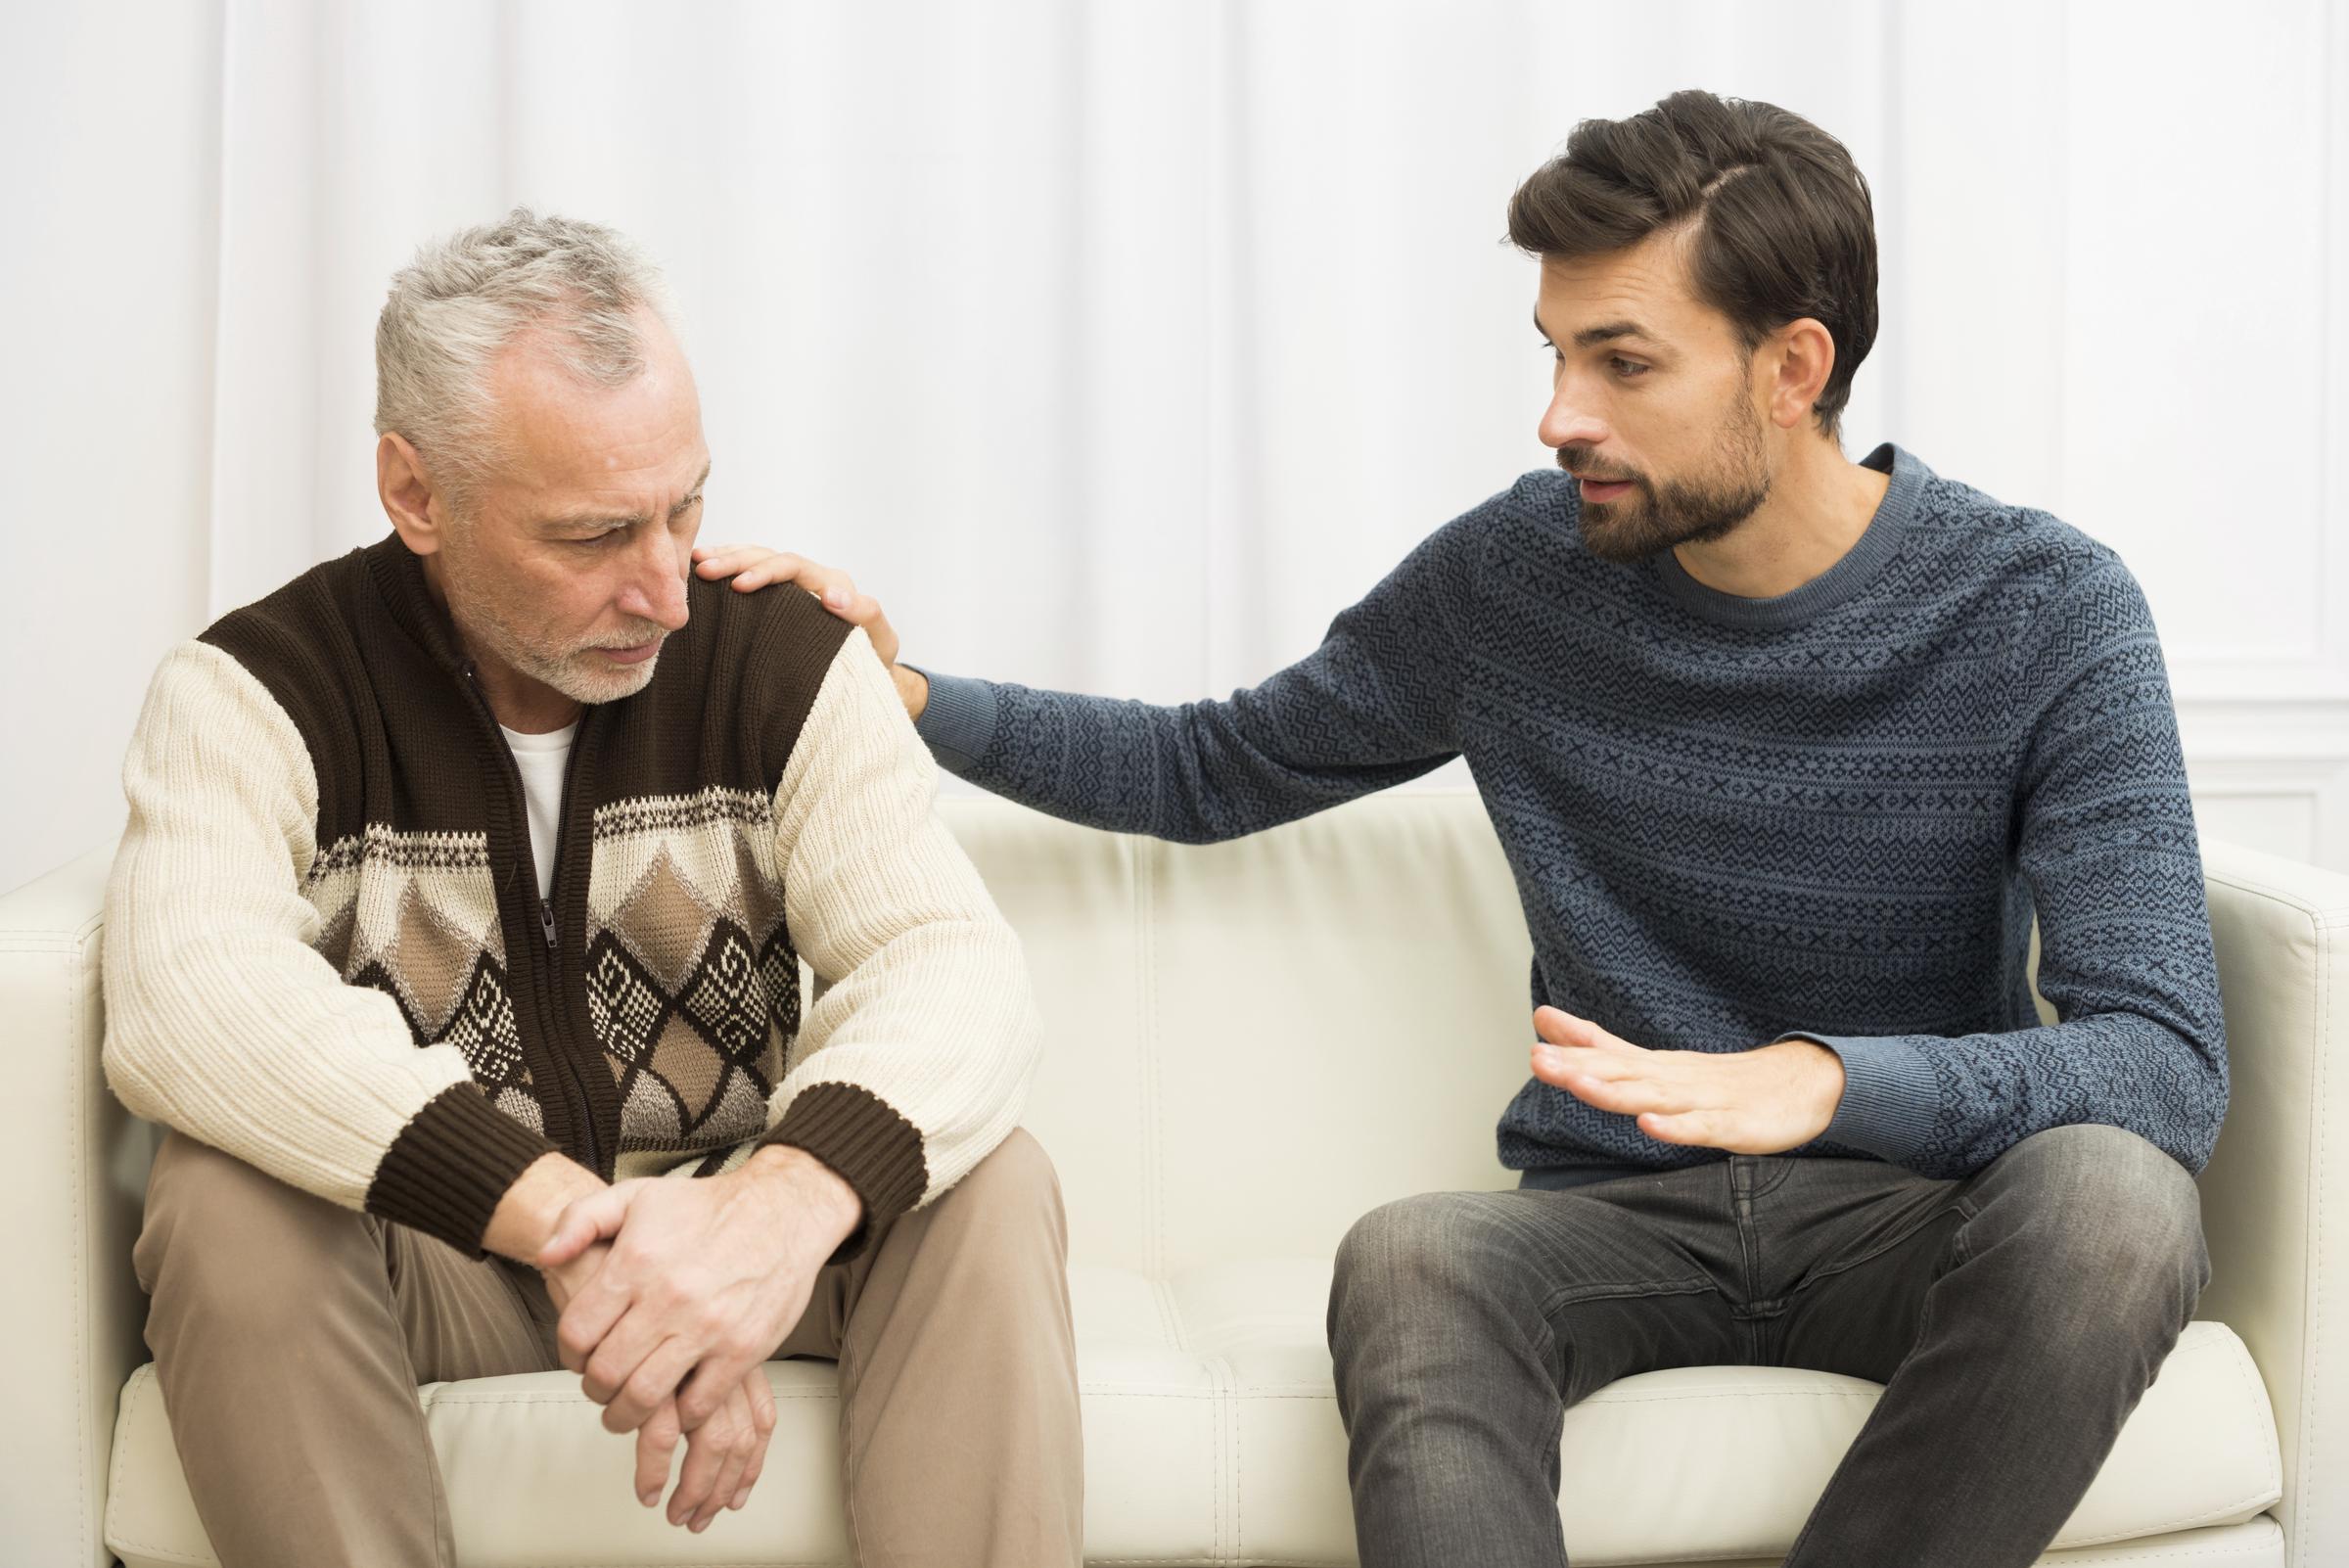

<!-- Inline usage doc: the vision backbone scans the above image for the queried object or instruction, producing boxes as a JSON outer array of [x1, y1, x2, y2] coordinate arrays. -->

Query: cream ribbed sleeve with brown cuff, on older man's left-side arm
[[104, 641, 552, 1254]]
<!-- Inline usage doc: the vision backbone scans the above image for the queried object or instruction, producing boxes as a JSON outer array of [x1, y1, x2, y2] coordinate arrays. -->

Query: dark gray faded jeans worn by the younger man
[[1329, 1127, 2210, 1568]]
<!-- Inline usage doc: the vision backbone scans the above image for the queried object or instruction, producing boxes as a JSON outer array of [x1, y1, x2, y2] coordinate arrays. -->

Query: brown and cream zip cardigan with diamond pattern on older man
[[104, 535, 1038, 1251]]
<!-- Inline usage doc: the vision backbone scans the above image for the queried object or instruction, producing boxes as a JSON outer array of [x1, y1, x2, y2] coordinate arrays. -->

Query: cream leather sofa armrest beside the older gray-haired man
[[0, 845, 155, 1568]]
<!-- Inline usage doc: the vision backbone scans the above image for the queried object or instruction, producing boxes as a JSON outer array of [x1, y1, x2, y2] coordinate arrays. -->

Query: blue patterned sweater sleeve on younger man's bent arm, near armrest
[[1780, 552, 2227, 1176]]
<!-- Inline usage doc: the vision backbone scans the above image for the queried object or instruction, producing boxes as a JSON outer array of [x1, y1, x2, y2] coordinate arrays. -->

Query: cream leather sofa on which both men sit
[[0, 794, 2349, 1568]]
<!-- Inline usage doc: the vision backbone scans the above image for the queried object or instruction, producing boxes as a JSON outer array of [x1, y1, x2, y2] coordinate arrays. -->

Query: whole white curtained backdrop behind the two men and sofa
[[0, 0, 2349, 885]]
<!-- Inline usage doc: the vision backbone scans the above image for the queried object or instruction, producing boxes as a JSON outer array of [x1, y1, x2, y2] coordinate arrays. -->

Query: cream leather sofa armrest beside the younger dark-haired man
[[2198, 841, 2349, 1566]]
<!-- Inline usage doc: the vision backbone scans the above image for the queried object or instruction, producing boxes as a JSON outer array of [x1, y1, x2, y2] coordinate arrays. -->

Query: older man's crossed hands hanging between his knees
[[505, 1145, 864, 1533]]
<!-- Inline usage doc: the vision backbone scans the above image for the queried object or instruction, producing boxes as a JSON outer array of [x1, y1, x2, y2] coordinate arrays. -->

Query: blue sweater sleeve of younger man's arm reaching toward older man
[[897, 497, 1503, 843]]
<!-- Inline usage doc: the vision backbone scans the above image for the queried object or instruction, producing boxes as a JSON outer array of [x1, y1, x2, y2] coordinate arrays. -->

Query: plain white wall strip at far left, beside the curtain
[[0, 5, 221, 888]]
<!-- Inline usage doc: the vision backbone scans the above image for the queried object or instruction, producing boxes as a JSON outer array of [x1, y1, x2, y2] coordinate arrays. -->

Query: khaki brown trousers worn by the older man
[[134, 1131, 1082, 1568]]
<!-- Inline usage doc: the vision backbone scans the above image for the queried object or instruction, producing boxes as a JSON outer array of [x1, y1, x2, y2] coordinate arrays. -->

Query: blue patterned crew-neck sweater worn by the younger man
[[921, 443, 2227, 1185]]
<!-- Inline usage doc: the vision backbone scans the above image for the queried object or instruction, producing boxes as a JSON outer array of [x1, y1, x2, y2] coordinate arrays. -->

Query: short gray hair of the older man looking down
[[376, 207, 676, 517]]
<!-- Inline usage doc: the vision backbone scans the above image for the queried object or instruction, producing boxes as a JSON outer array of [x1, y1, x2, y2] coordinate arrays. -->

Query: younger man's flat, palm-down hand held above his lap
[[1534, 1007, 1844, 1155]]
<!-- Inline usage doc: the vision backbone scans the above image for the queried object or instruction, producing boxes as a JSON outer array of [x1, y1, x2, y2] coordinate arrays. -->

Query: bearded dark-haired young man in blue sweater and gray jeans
[[723, 92, 2227, 1568]]
